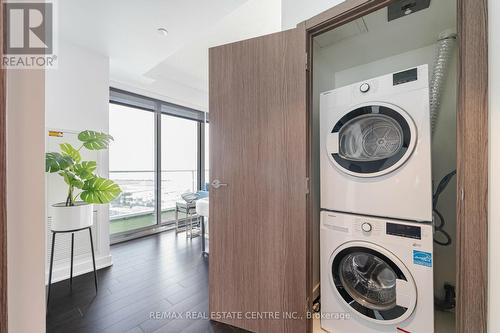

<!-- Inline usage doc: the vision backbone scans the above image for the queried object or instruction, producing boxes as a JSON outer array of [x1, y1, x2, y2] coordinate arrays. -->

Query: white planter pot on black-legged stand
[[50, 202, 94, 231]]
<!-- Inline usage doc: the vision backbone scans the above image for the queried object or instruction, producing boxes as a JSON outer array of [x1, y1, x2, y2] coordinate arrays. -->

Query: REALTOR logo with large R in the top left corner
[[2, 1, 57, 69]]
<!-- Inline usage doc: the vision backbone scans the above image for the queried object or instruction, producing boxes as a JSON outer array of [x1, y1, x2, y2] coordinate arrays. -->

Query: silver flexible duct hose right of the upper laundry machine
[[429, 33, 457, 136]]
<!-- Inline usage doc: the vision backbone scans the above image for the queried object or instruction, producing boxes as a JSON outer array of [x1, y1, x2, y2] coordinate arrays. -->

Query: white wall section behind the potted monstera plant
[[44, 40, 112, 281]]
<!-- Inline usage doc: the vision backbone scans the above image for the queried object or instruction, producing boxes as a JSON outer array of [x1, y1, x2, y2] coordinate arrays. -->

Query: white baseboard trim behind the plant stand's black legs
[[45, 255, 113, 285]]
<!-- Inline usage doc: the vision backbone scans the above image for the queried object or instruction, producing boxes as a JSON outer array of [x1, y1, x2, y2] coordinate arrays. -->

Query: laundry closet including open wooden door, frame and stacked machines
[[209, 0, 487, 333]]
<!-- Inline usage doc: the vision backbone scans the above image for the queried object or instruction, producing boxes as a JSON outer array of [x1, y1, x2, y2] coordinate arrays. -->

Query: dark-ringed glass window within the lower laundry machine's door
[[332, 247, 415, 323]]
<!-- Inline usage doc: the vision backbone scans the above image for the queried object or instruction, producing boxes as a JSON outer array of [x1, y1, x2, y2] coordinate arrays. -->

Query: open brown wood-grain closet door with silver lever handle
[[209, 26, 309, 333]]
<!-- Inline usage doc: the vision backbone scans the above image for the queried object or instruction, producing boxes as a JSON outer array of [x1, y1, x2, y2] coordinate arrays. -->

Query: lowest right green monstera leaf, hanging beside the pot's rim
[[80, 177, 122, 204]]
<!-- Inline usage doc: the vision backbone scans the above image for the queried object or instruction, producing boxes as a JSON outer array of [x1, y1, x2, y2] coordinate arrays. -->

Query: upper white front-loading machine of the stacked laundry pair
[[320, 65, 432, 222]]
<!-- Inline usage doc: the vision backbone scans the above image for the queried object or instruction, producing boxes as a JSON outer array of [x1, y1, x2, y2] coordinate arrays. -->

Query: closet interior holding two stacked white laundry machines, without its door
[[312, 0, 458, 333]]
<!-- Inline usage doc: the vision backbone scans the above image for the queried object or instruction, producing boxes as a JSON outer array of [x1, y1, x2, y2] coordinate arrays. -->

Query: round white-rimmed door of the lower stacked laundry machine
[[330, 242, 417, 325]]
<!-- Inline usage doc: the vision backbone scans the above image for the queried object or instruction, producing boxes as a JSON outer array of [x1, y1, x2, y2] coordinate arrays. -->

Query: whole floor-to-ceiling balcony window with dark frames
[[109, 89, 208, 241]]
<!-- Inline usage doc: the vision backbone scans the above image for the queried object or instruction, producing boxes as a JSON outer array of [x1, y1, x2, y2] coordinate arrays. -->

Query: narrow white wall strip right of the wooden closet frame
[[488, 0, 500, 332]]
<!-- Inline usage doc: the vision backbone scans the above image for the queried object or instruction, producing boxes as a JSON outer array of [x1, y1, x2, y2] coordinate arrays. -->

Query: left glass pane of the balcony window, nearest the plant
[[109, 104, 157, 236]]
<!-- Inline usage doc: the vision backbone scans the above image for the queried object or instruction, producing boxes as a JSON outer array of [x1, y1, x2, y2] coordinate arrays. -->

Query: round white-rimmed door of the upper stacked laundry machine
[[327, 102, 417, 177]]
